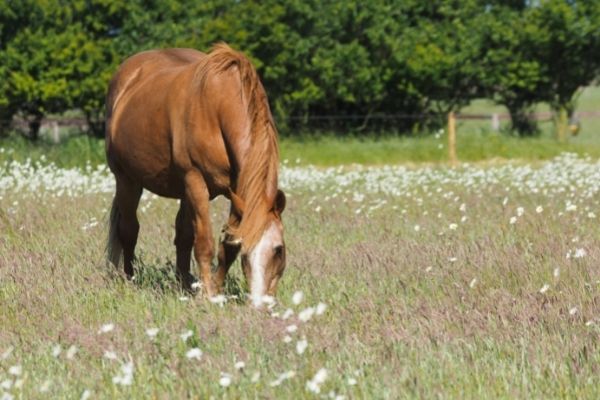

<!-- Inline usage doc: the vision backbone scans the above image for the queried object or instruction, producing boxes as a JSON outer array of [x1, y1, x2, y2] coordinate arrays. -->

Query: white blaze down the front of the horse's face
[[250, 222, 282, 307]]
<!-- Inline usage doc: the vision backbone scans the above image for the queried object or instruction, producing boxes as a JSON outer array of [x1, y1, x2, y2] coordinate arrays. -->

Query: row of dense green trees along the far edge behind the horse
[[0, 0, 600, 139]]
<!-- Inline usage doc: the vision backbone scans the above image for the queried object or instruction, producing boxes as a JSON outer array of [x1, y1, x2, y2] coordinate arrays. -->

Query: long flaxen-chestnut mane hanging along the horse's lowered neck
[[195, 43, 279, 249]]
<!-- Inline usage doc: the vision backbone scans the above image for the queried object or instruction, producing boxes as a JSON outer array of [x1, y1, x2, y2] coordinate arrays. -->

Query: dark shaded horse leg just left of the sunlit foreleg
[[175, 198, 194, 290]]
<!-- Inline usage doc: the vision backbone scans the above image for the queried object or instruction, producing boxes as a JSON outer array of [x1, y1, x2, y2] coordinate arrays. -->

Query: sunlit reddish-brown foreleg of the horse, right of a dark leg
[[185, 172, 218, 297]]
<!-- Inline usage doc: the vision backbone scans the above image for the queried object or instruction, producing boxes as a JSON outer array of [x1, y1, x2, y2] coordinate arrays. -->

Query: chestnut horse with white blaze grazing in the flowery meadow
[[106, 44, 285, 307]]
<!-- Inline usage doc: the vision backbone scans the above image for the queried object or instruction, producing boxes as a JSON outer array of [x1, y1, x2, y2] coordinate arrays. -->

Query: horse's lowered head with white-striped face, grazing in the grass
[[232, 190, 286, 307]]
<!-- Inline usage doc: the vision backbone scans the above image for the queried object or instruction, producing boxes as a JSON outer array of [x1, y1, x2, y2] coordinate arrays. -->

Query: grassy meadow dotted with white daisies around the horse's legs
[[0, 154, 600, 399]]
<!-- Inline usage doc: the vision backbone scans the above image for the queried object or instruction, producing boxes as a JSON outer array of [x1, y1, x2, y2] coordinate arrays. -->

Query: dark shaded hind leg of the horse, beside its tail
[[115, 175, 142, 278]]
